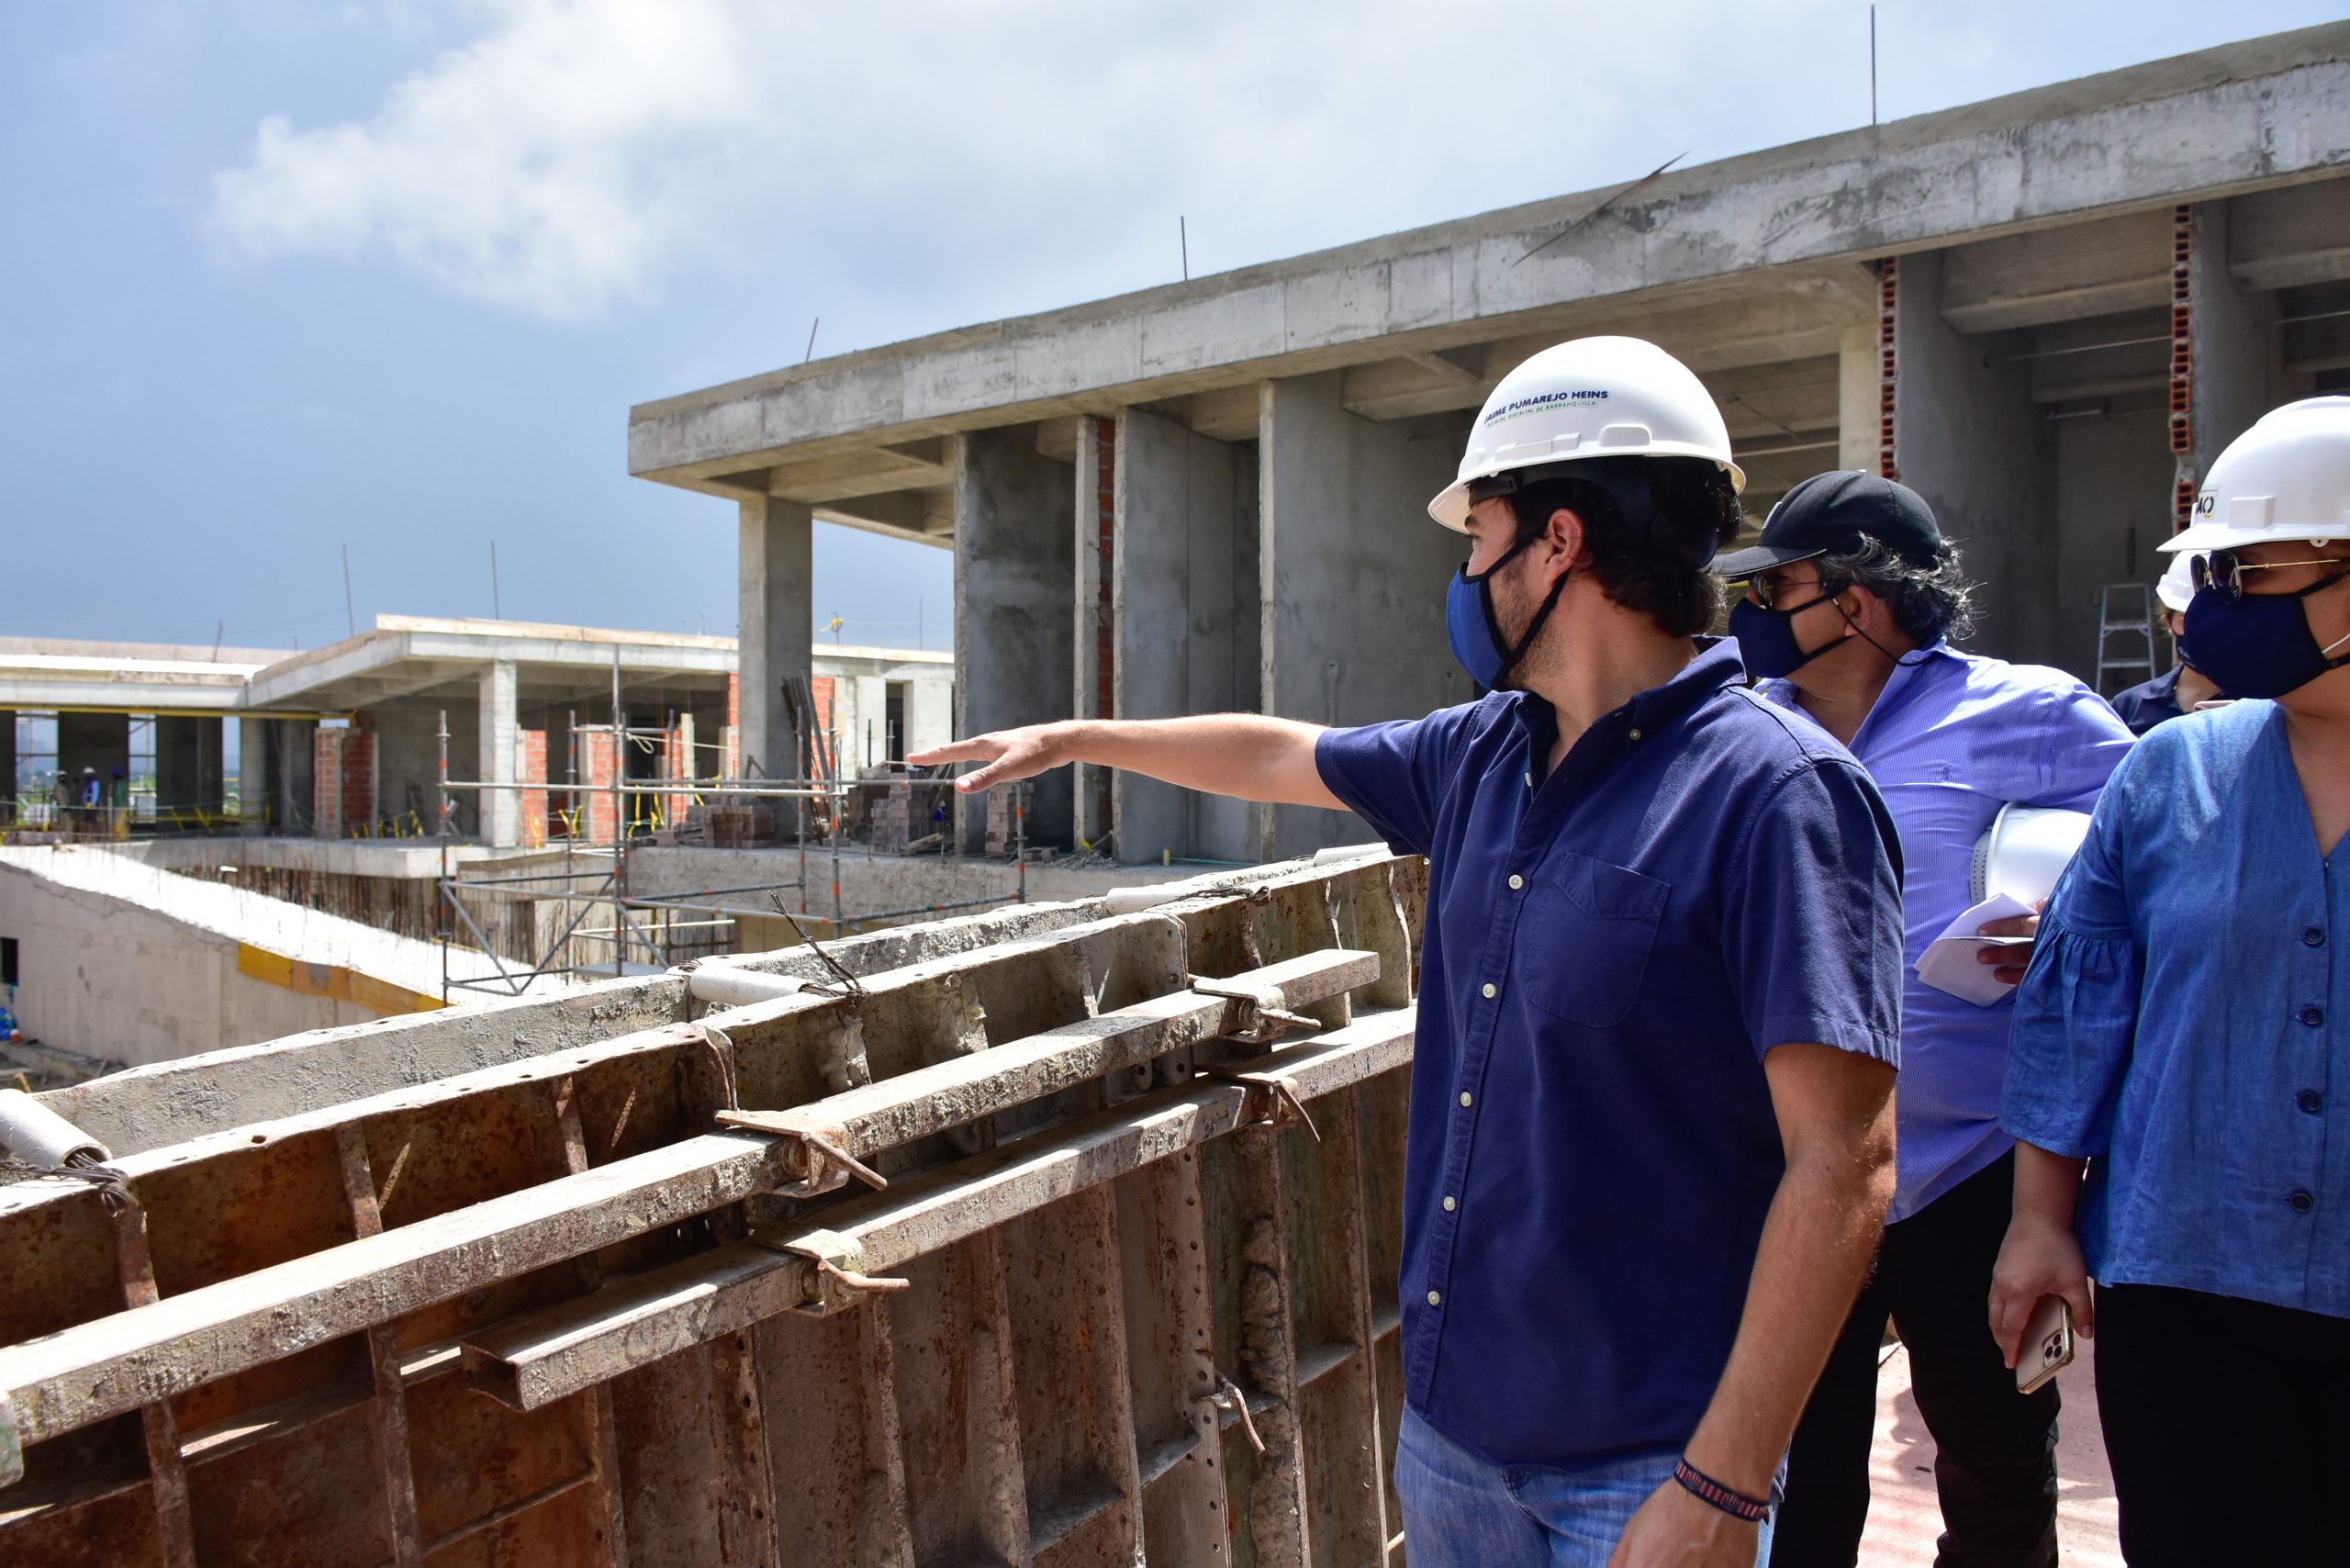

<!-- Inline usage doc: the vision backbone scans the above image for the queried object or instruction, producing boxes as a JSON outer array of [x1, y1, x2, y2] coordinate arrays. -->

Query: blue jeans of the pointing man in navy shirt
[[1396, 1406, 1770, 1568]]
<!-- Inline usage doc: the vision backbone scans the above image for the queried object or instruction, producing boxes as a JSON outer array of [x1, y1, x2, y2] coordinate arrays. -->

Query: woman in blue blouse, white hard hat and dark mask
[[1990, 398, 2350, 1568]]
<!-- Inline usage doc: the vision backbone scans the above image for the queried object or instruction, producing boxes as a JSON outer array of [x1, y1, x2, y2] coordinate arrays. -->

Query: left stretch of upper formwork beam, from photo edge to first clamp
[[0, 1133, 788, 1441]]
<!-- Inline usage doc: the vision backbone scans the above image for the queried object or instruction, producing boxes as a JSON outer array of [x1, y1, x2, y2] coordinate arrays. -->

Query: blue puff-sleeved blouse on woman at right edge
[[2000, 703, 2350, 1316]]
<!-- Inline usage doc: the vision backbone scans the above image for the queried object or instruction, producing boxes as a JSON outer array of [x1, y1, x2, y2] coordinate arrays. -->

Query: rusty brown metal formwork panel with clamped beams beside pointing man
[[0, 856, 1424, 1568]]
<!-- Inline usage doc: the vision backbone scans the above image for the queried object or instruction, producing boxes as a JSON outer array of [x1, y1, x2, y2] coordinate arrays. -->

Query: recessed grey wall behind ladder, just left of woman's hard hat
[[2049, 395, 2171, 689]]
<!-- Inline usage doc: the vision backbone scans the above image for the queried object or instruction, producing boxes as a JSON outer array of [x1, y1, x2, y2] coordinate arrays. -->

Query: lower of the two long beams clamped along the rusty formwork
[[463, 1009, 1415, 1410]]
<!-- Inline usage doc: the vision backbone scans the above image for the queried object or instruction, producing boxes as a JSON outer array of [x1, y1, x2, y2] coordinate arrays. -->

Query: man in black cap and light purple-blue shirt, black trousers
[[1713, 473, 2132, 1568]]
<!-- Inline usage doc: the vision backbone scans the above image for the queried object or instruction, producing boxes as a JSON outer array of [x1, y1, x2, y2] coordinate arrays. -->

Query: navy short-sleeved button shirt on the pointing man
[[1316, 640, 1901, 1467]]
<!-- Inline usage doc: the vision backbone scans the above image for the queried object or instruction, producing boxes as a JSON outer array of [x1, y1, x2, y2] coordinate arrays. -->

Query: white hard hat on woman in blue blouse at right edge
[[2160, 398, 2350, 553]]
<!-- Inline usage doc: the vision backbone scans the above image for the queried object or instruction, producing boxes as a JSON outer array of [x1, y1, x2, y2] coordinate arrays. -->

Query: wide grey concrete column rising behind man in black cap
[[1894, 252, 2064, 666]]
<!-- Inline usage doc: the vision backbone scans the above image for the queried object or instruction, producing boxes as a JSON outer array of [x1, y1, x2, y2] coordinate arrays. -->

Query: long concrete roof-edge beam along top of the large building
[[630, 24, 2350, 485]]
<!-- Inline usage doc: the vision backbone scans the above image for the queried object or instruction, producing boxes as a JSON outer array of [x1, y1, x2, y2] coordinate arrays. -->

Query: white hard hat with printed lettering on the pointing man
[[1428, 339, 1746, 532]]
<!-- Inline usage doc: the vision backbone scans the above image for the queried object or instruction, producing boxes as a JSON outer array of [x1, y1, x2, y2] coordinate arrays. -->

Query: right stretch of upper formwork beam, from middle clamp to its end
[[719, 947, 1380, 1157]]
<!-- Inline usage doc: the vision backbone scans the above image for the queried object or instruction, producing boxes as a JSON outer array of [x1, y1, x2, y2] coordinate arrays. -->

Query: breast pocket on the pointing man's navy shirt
[[1511, 851, 1669, 1030]]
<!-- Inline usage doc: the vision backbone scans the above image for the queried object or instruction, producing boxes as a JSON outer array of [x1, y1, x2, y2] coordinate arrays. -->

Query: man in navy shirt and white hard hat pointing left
[[916, 339, 1901, 1568]]
